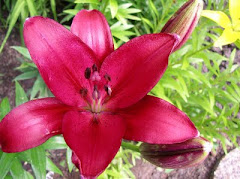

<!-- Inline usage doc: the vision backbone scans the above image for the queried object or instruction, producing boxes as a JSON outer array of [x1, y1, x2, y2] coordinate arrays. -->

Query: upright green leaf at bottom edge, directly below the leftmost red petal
[[31, 146, 46, 179]]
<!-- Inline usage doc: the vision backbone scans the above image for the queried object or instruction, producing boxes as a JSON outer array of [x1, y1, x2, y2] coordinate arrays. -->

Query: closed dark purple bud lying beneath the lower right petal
[[140, 137, 212, 169]]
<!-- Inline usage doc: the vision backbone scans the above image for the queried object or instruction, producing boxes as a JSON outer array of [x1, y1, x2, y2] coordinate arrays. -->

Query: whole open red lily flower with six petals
[[0, 10, 198, 178]]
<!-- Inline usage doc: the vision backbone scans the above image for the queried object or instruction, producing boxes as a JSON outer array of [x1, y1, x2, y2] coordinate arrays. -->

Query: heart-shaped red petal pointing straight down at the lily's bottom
[[63, 111, 125, 178]]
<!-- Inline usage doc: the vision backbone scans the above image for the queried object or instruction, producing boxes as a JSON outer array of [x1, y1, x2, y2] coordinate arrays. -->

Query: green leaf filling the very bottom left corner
[[0, 153, 17, 178]]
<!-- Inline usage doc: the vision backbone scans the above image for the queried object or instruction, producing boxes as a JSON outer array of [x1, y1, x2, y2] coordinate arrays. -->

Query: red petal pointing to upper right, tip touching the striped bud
[[101, 33, 177, 108]]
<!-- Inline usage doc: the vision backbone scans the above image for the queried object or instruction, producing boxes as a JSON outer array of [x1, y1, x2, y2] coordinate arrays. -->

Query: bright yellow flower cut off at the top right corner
[[202, 0, 240, 47]]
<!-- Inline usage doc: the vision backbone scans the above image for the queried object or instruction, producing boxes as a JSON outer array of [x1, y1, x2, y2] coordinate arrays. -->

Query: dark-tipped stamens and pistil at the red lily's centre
[[80, 64, 112, 113]]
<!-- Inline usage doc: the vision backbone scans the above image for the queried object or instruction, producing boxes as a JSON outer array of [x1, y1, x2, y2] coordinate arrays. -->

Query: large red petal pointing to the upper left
[[24, 17, 96, 106]]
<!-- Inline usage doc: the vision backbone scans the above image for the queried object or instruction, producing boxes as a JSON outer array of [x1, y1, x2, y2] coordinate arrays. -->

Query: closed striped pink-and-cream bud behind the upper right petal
[[161, 0, 203, 51]]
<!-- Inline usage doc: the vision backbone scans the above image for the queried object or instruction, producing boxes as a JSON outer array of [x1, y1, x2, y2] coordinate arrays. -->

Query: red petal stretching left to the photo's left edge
[[0, 98, 69, 152]]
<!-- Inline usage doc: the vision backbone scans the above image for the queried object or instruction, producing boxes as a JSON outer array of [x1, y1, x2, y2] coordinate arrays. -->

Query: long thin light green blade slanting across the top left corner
[[0, 0, 25, 53]]
